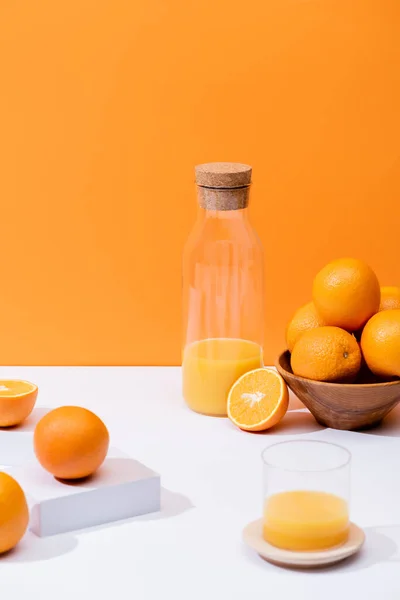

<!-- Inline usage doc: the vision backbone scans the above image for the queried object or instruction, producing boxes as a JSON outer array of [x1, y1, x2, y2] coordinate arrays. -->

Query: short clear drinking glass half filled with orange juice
[[263, 441, 350, 551]]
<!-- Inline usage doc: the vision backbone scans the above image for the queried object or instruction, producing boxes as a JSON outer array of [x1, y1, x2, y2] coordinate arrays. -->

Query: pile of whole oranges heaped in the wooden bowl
[[286, 258, 400, 383]]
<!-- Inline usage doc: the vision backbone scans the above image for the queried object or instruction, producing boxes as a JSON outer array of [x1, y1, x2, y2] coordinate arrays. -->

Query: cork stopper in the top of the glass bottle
[[195, 163, 252, 210]]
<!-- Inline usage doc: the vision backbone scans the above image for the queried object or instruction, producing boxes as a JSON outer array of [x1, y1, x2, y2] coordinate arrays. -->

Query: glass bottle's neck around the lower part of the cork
[[197, 186, 250, 213]]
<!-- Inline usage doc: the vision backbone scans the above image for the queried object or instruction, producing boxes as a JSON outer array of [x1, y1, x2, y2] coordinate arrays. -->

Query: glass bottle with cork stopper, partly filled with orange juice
[[182, 163, 264, 417]]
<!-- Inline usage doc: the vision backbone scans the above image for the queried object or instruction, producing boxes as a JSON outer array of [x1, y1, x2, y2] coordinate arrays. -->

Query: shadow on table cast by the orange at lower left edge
[[0, 532, 78, 565]]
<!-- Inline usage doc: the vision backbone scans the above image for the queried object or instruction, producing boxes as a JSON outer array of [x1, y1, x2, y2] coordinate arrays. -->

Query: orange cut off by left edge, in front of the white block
[[0, 473, 29, 554]]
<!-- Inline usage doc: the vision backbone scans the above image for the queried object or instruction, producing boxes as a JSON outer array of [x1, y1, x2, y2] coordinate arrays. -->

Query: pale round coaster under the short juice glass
[[243, 519, 365, 569]]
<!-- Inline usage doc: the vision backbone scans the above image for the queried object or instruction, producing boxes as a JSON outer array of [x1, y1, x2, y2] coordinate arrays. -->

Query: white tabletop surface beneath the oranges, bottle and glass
[[0, 367, 400, 600]]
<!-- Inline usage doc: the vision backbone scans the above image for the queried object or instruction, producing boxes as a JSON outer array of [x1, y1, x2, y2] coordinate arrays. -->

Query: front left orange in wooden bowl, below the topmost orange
[[291, 326, 361, 383]]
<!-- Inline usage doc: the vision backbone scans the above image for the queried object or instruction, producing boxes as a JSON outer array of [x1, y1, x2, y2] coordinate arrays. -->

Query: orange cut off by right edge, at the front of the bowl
[[361, 309, 400, 378]]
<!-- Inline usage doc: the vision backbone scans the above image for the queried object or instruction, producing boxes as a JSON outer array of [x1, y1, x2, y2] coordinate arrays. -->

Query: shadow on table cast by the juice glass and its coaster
[[245, 525, 400, 576]]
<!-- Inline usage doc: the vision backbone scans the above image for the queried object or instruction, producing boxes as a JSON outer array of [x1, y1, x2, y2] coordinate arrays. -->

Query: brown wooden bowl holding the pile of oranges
[[275, 351, 400, 430]]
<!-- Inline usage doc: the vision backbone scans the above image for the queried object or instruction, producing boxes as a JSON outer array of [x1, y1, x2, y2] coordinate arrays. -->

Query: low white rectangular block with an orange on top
[[3, 449, 161, 537]]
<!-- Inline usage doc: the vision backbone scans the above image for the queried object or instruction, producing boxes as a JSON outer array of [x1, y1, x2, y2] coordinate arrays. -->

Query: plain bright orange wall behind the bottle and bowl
[[0, 0, 400, 365]]
